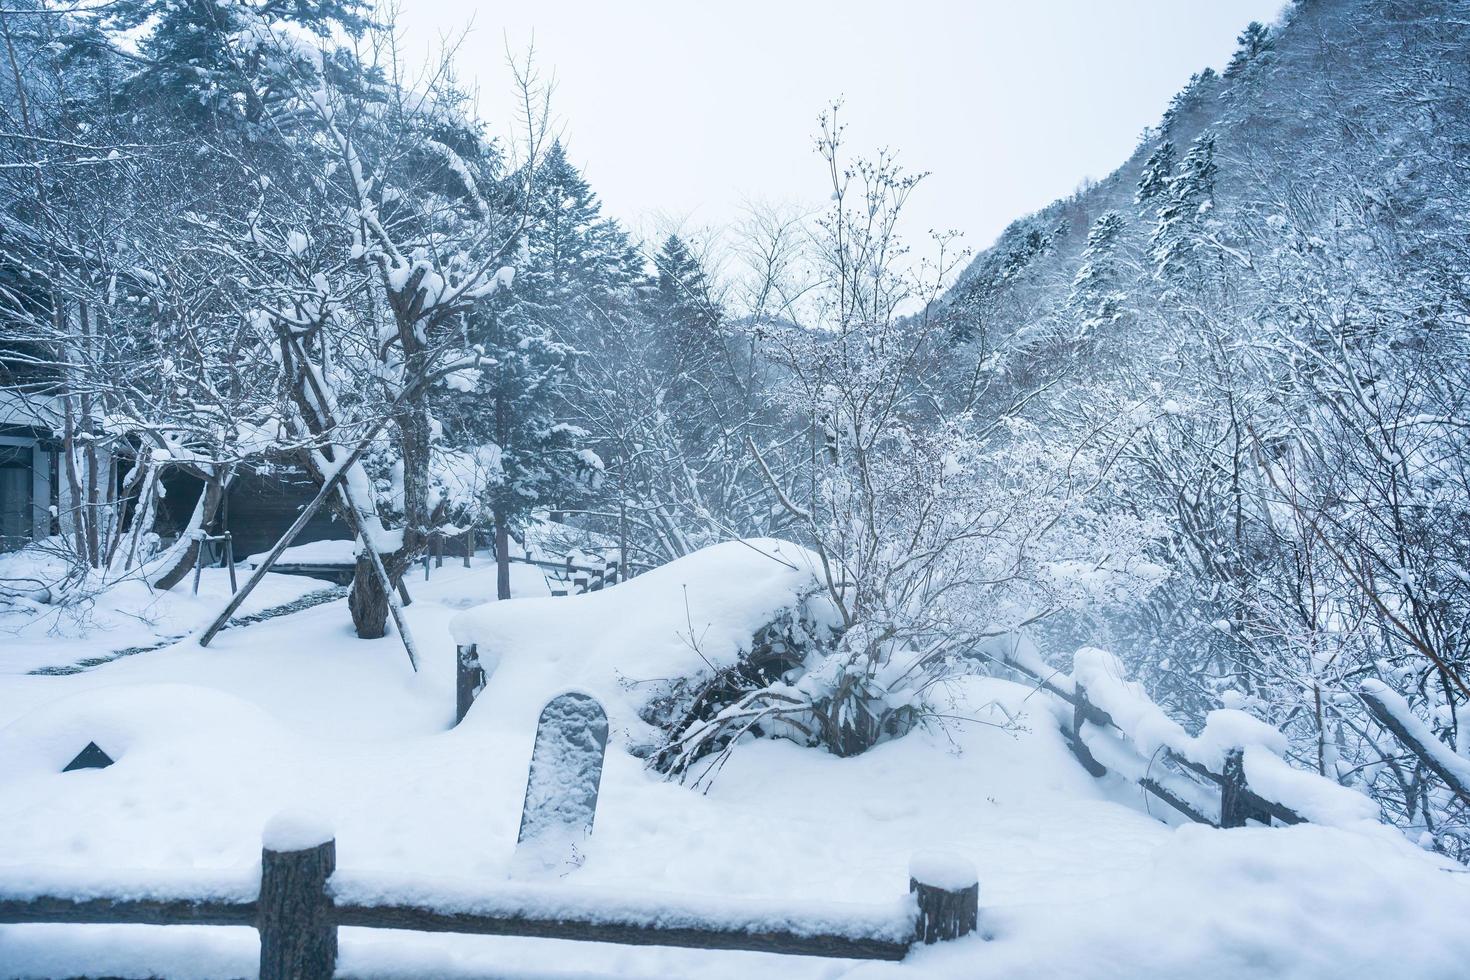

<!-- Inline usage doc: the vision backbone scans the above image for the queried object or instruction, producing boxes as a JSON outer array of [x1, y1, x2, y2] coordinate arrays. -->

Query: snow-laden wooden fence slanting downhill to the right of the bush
[[995, 648, 1377, 827]]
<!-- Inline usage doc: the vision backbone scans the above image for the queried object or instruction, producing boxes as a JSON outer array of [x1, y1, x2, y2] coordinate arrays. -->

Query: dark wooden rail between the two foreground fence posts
[[335, 905, 908, 961]]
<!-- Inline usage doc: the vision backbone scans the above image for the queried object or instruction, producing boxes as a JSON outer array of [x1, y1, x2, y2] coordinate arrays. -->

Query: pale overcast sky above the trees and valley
[[401, 0, 1282, 258]]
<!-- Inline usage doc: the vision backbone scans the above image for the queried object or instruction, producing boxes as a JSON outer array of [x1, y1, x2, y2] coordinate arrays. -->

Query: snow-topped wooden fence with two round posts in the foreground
[[0, 817, 979, 980]]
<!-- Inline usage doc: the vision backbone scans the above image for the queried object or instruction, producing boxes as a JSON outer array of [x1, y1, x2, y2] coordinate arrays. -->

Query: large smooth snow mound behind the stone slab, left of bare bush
[[450, 538, 831, 732]]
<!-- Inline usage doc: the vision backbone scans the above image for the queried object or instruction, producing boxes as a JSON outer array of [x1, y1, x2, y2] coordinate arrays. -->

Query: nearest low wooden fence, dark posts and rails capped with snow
[[0, 832, 979, 980]]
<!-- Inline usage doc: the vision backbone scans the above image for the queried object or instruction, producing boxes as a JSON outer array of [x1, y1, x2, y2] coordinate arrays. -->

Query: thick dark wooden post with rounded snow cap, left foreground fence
[[256, 817, 337, 980]]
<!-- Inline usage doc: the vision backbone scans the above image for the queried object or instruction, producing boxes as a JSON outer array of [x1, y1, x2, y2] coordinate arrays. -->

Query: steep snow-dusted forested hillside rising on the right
[[941, 0, 1470, 855]]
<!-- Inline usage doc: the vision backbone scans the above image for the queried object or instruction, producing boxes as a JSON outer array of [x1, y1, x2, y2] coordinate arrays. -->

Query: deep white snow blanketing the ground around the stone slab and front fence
[[0, 545, 1470, 979]]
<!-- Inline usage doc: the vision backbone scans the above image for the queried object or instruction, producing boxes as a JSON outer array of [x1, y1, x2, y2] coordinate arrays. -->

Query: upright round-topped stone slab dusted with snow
[[515, 692, 607, 874]]
